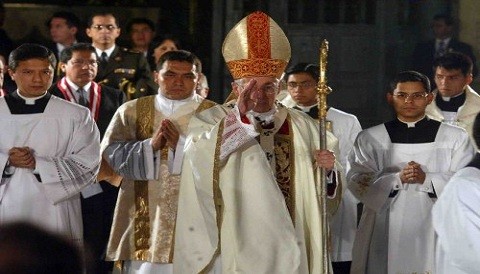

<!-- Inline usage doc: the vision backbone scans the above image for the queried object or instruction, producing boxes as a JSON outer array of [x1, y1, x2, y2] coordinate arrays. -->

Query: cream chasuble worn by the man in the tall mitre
[[174, 103, 337, 274]]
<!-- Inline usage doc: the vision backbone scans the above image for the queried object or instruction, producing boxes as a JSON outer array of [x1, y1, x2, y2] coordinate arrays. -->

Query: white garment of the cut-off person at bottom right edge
[[432, 167, 480, 274]]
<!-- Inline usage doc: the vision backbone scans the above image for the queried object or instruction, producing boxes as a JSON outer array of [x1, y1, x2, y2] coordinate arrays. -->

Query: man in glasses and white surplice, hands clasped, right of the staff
[[347, 71, 475, 274]]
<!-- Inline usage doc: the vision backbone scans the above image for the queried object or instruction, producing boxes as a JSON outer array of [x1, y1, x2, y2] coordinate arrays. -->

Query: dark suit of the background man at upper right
[[412, 38, 478, 87]]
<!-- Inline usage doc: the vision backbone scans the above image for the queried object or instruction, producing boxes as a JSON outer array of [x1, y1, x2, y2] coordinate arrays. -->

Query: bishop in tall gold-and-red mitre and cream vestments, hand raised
[[173, 12, 341, 274]]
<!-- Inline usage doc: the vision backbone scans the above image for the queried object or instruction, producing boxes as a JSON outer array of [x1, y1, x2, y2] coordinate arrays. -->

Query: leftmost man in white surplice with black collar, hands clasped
[[0, 44, 100, 246]]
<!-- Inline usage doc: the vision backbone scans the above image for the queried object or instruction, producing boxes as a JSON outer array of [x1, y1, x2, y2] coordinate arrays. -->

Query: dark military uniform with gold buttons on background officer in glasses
[[95, 46, 158, 100]]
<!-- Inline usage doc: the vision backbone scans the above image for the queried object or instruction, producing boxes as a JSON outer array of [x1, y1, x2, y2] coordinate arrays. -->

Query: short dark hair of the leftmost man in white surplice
[[8, 43, 57, 71]]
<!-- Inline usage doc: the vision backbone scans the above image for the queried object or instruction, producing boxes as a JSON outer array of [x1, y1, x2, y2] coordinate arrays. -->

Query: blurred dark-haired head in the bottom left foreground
[[0, 222, 84, 274]]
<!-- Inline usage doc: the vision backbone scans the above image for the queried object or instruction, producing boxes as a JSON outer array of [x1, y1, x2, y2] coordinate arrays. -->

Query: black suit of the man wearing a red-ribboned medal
[[49, 84, 125, 274]]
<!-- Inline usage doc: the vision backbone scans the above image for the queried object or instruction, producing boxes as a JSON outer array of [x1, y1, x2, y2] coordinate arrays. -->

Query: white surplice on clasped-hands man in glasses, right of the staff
[[347, 124, 474, 274]]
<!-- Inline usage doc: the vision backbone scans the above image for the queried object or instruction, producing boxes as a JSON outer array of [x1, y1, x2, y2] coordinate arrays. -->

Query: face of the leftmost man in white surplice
[[9, 59, 53, 98]]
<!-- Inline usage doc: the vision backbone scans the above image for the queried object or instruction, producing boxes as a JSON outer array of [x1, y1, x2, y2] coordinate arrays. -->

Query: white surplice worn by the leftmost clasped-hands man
[[0, 96, 100, 244]]
